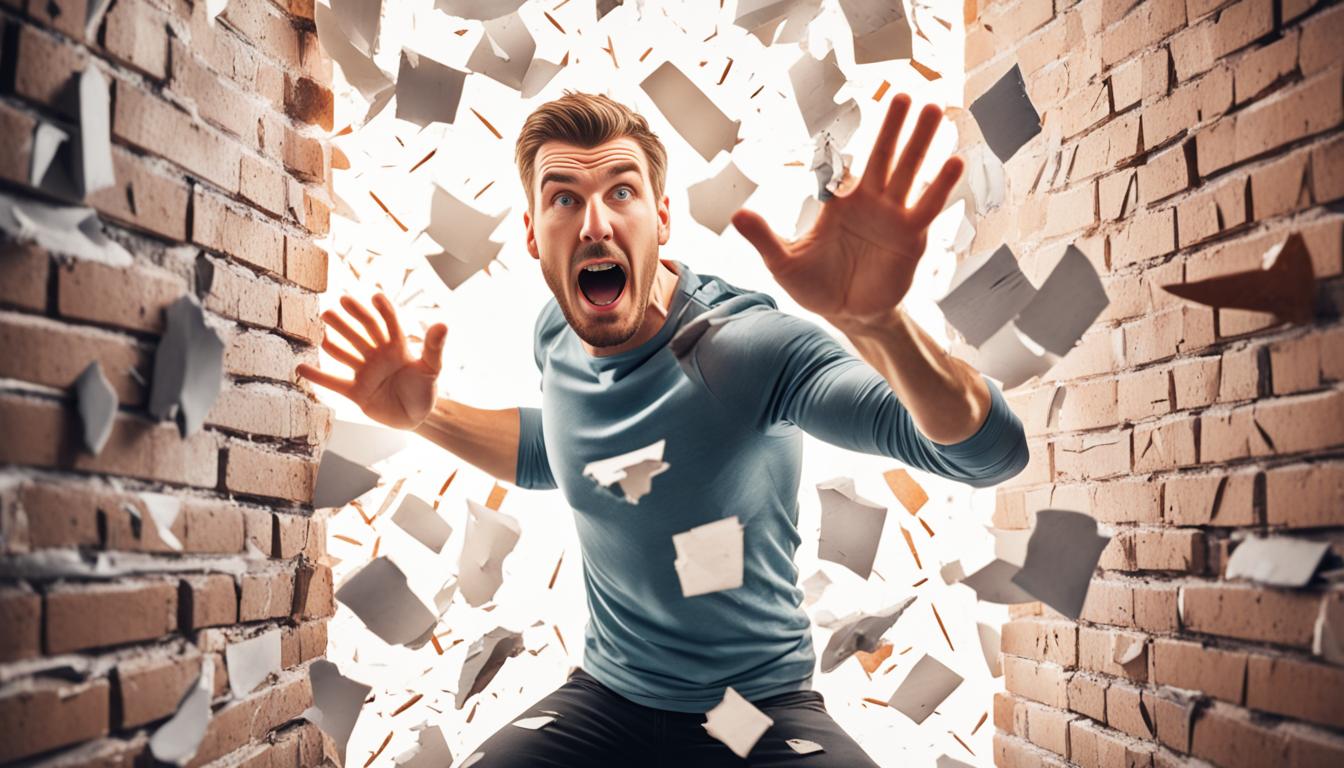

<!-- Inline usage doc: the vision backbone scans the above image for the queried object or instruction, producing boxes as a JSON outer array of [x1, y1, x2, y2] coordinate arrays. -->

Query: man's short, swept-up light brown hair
[[513, 89, 668, 211]]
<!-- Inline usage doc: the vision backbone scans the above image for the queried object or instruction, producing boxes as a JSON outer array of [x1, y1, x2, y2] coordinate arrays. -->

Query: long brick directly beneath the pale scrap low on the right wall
[[1181, 584, 1320, 648]]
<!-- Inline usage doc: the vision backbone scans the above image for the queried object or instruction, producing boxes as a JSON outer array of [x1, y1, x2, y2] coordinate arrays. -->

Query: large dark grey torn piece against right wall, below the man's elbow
[[1012, 510, 1110, 620]]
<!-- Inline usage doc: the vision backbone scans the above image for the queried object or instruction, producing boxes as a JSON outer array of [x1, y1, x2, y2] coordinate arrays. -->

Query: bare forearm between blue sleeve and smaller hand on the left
[[414, 397, 519, 483]]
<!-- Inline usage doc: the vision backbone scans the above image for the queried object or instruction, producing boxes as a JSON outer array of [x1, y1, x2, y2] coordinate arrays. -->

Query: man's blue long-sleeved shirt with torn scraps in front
[[516, 261, 1027, 713]]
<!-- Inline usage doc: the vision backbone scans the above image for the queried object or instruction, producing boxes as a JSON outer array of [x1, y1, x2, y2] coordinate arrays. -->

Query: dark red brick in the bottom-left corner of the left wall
[[0, 677, 109, 763]]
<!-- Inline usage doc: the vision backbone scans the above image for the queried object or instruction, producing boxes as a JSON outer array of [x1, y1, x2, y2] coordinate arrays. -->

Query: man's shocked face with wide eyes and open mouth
[[523, 136, 668, 347]]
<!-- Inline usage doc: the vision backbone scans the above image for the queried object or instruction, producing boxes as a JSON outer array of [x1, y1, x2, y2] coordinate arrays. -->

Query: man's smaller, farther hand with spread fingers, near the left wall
[[297, 293, 448, 429]]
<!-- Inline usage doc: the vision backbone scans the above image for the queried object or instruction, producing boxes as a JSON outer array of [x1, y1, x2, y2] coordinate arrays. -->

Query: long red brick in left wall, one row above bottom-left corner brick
[[43, 580, 177, 654]]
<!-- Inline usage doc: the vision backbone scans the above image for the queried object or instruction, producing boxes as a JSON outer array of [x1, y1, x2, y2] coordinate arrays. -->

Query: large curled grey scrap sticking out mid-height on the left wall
[[148, 293, 224, 437]]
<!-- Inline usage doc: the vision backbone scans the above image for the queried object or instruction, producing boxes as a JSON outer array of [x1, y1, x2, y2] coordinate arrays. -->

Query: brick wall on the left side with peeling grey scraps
[[0, 0, 335, 768]]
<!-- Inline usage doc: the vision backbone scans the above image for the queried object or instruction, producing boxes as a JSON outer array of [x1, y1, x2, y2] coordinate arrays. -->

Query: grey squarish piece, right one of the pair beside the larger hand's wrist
[[1013, 245, 1110, 356]]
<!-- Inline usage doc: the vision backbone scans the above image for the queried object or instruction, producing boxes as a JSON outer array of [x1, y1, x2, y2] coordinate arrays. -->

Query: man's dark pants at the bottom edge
[[466, 668, 878, 768]]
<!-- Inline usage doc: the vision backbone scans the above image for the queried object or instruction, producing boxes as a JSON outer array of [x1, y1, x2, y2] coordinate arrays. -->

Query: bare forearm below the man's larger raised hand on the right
[[836, 305, 991, 445]]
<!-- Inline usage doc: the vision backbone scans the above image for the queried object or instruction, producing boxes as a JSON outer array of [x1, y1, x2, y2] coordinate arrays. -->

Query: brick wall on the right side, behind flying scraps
[[958, 0, 1344, 767]]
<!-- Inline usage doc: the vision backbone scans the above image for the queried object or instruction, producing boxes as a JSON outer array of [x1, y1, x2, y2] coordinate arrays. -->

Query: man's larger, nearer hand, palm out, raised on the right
[[731, 94, 962, 327]]
